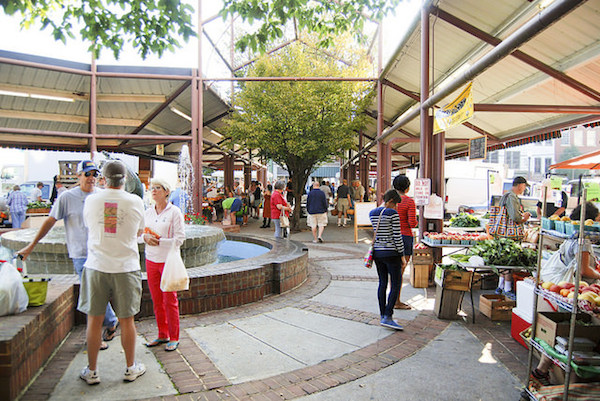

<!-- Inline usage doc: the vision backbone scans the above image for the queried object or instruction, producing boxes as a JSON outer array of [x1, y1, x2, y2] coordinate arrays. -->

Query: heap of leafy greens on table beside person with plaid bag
[[469, 238, 537, 267]]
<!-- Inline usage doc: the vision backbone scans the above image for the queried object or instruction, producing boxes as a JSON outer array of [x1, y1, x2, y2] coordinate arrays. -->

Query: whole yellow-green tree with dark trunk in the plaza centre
[[227, 42, 373, 228]]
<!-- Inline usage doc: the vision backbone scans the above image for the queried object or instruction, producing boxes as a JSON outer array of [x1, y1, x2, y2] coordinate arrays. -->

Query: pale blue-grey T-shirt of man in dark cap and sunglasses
[[50, 187, 97, 259]]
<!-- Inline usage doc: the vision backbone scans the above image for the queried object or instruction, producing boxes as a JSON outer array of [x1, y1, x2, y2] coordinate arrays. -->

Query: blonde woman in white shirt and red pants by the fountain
[[142, 178, 185, 351]]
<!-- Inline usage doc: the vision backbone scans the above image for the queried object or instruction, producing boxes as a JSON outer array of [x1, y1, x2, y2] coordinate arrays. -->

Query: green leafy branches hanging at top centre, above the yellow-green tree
[[221, 0, 401, 52]]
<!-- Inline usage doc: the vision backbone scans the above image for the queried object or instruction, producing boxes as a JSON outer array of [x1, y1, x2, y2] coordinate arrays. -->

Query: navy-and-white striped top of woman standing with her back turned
[[369, 207, 404, 257]]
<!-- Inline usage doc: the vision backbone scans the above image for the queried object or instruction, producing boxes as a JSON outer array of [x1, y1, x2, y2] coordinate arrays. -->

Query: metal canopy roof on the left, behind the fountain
[[0, 50, 255, 165]]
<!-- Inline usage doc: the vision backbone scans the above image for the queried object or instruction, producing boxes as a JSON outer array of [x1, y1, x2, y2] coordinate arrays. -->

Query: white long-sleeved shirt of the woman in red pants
[[138, 203, 185, 263]]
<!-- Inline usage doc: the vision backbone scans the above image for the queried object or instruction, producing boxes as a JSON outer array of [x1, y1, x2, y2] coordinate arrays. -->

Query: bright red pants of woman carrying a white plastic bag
[[146, 259, 179, 341]]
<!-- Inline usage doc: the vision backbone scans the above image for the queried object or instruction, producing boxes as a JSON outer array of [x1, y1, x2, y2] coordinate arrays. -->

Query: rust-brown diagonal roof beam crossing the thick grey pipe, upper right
[[431, 6, 600, 102]]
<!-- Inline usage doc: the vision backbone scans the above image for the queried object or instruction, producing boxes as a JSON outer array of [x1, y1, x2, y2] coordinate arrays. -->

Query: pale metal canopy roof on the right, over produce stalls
[[366, 0, 600, 168]]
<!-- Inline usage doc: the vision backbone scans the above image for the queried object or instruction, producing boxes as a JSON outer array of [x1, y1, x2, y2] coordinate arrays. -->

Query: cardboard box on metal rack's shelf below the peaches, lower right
[[535, 312, 600, 347]]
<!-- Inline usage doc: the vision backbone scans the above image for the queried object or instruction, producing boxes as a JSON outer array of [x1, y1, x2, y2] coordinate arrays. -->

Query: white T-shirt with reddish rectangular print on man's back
[[83, 188, 144, 273]]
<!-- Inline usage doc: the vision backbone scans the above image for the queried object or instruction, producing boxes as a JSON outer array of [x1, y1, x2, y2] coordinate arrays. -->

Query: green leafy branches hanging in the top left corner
[[0, 0, 196, 58]]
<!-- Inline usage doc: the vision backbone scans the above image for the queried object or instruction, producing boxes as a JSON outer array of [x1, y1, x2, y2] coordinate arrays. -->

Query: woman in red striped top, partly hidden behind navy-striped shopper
[[394, 175, 418, 309]]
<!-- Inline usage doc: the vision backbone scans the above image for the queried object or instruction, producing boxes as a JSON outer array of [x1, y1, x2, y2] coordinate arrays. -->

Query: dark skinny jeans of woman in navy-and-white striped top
[[373, 255, 402, 317]]
